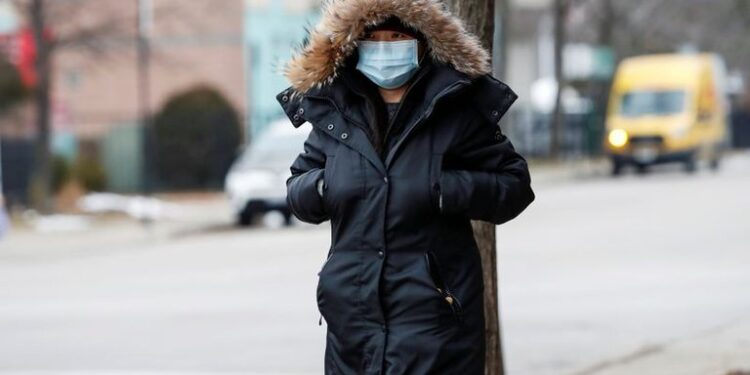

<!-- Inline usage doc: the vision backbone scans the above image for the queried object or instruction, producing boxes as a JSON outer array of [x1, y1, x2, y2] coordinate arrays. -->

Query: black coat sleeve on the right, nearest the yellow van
[[439, 114, 535, 224]]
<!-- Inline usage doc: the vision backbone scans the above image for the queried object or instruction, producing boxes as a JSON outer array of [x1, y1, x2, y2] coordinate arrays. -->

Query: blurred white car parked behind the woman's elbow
[[225, 118, 312, 226]]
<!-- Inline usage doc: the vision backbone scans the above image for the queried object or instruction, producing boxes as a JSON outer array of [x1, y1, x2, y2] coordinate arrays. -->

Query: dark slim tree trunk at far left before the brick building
[[28, 0, 53, 213]]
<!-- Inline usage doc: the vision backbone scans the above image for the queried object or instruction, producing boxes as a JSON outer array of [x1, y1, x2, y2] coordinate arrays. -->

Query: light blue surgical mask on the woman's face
[[357, 39, 419, 89]]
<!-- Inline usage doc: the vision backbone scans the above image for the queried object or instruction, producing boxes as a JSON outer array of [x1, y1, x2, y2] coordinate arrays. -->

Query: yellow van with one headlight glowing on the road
[[604, 54, 729, 174]]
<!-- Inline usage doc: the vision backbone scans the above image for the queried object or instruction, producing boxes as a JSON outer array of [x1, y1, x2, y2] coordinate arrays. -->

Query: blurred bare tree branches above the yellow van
[[568, 0, 750, 76]]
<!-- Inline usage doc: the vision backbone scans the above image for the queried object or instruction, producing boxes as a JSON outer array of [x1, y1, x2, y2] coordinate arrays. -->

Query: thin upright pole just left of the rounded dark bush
[[135, 0, 155, 200]]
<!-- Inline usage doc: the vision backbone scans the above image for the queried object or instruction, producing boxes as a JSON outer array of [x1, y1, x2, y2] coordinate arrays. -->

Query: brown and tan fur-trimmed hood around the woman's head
[[283, 0, 491, 93]]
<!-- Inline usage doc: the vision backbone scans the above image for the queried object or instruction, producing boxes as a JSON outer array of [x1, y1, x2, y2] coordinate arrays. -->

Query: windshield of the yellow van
[[620, 90, 685, 117]]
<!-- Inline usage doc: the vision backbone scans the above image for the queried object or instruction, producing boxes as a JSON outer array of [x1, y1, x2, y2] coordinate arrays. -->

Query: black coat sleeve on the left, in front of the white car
[[286, 128, 330, 224]]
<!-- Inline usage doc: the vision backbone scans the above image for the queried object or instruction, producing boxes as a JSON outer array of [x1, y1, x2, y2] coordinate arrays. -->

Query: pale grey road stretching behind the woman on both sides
[[0, 154, 750, 375]]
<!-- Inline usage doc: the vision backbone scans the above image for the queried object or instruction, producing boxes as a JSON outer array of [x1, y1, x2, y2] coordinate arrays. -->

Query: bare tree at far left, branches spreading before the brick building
[[14, 0, 191, 212]]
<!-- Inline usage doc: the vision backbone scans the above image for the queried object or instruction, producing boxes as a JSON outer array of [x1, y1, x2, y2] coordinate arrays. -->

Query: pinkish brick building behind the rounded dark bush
[[0, 0, 247, 191]]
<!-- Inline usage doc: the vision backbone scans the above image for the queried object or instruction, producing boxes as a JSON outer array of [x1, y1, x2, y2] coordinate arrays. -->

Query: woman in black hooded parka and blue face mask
[[277, 0, 534, 374]]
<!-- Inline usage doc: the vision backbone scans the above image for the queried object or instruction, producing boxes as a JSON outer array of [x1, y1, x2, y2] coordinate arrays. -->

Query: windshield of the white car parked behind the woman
[[238, 134, 307, 170]]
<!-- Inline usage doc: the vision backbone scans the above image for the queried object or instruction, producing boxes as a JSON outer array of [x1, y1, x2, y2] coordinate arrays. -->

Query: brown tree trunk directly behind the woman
[[445, 0, 505, 375]]
